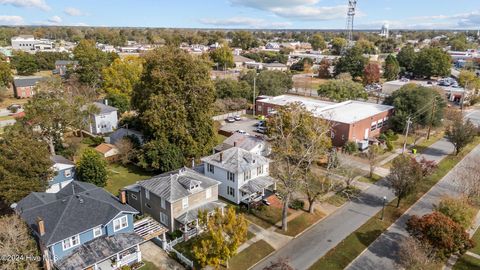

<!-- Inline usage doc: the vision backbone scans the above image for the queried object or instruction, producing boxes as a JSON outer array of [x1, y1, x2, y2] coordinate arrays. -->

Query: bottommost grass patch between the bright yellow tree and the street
[[228, 240, 275, 270]]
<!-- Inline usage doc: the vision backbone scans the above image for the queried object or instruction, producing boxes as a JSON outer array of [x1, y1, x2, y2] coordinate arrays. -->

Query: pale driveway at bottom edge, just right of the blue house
[[140, 241, 185, 270]]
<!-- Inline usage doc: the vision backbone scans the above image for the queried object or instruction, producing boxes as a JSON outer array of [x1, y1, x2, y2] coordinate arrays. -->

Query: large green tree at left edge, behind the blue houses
[[0, 124, 53, 204]]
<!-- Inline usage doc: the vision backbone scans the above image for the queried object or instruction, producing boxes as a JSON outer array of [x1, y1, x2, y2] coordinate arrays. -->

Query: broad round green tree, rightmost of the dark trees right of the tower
[[414, 48, 452, 78]]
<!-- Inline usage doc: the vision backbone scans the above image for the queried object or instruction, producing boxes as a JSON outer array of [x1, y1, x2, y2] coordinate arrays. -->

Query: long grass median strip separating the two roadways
[[310, 137, 480, 270]]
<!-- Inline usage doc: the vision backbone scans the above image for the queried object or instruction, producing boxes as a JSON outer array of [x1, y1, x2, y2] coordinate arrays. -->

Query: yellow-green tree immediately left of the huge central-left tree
[[102, 56, 143, 97]]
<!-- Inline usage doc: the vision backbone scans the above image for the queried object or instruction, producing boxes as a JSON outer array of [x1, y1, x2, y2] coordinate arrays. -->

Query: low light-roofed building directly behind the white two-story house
[[215, 132, 270, 156]]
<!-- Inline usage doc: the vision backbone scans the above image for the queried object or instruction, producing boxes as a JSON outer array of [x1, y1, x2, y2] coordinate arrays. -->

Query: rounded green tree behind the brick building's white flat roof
[[317, 76, 368, 102]]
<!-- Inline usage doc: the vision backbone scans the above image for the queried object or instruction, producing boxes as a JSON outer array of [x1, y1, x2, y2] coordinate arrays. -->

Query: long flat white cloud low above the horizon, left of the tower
[[200, 17, 291, 28]]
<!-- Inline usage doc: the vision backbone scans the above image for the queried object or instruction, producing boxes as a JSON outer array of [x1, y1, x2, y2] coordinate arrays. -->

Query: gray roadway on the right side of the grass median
[[347, 141, 480, 270]]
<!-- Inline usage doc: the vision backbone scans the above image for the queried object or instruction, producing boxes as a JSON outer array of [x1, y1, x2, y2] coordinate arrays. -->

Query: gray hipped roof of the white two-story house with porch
[[202, 147, 269, 173]]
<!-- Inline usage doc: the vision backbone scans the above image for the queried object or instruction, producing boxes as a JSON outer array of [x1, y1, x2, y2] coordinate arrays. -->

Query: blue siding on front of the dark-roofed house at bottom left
[[49, 213, 133, 260]]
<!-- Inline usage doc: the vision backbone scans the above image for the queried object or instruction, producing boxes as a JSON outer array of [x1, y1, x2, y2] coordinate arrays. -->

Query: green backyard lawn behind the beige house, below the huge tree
[[105, 164, 153, 195]]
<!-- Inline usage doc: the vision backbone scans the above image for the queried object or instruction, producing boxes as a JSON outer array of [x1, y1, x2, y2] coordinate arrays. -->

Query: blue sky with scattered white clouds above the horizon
[[0, 0, 480, 30]]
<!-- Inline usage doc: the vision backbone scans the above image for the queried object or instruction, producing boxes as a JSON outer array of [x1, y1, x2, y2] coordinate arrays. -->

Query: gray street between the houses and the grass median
[[253, 140, 453, 269]]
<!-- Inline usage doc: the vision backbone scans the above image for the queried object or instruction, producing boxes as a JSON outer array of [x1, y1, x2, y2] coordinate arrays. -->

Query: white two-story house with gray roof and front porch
[[202, 147, 276, 204]]
